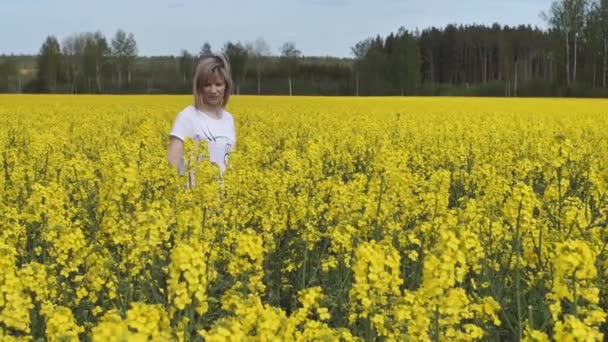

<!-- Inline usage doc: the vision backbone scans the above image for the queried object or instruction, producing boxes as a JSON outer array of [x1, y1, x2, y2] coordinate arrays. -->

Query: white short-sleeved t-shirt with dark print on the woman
[[169, 105, 236, 173]]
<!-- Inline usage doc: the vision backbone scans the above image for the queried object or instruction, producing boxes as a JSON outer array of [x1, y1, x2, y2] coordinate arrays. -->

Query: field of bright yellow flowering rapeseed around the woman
[[0, 95, 608, 341]]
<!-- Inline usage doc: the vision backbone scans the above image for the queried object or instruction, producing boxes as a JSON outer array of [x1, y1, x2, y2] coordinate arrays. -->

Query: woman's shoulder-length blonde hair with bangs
[[192, 54, 232, 109]]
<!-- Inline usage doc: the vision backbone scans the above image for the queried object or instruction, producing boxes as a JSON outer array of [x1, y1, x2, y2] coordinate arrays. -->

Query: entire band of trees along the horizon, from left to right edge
[[0, 0, 608, 96]]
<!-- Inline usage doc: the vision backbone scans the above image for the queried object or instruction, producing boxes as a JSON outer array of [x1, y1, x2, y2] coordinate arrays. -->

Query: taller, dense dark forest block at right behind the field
[[352, 0, 608, 96]]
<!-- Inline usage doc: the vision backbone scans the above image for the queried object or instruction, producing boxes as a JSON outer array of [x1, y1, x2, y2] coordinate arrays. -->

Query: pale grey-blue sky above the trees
[[0, 0, 552, 57]]
